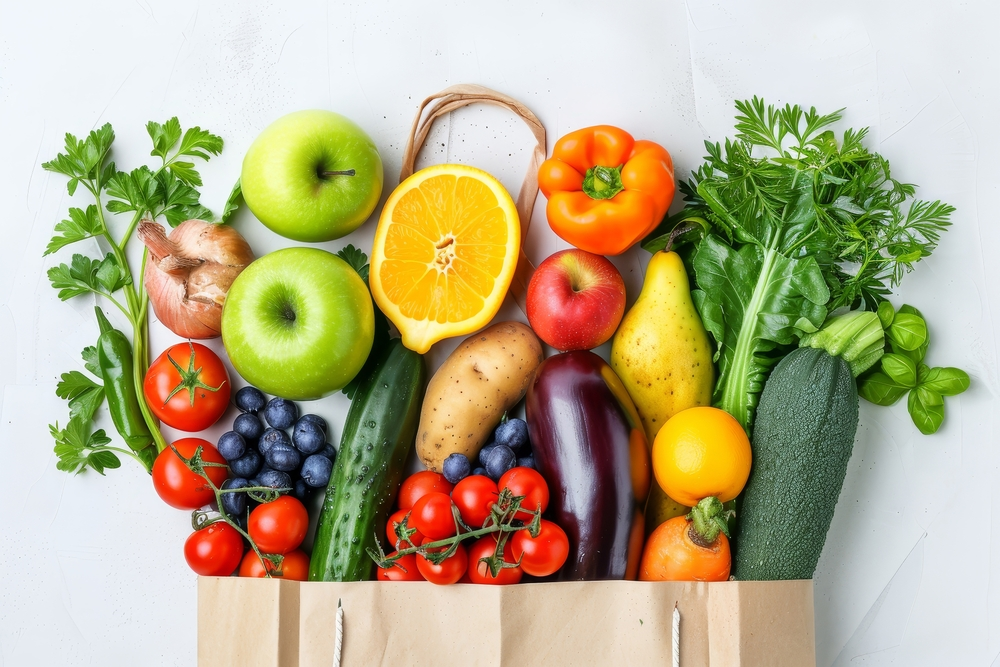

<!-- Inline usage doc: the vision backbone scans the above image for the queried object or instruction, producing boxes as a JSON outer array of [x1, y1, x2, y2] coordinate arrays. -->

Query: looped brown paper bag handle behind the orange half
[[399, 83, 545, 314]]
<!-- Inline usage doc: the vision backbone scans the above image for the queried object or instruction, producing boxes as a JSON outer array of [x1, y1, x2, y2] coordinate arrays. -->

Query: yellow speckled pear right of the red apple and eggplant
[[611, 251, 715, 444]]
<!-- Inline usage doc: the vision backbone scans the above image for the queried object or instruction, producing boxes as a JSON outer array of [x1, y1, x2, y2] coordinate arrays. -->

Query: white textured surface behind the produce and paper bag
[[0, 0, 1000, 667]]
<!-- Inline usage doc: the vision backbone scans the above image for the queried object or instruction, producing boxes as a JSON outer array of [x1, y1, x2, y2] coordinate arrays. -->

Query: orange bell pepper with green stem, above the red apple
[[538, 125, 674, 255]]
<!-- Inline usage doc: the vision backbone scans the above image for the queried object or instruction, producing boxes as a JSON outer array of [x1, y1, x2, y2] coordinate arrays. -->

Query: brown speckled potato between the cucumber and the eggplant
[[417, 322, 544, 472]]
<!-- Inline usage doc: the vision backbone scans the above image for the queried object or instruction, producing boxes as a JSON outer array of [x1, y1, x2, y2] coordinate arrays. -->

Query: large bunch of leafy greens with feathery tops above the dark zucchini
[[643, 97, 954, 430]]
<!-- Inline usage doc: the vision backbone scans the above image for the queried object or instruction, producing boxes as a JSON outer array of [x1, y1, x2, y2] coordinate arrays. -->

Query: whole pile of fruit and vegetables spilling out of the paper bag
[[44, 87, 970, 584]]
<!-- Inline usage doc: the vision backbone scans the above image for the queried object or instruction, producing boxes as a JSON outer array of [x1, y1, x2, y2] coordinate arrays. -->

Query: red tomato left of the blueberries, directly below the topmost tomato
[[153, 438, 229, 510]]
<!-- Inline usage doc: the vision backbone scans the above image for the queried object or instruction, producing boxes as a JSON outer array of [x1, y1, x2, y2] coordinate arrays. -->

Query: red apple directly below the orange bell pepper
[[528, 249, 625, 352]]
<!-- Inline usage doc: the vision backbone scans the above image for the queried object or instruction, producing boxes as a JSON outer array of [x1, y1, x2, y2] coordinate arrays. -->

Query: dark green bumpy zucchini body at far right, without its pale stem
[[733, 348, 864, 581]]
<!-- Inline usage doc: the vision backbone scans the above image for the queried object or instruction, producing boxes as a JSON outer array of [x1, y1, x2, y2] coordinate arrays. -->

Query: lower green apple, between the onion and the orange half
[[222, 248, 375, 400]]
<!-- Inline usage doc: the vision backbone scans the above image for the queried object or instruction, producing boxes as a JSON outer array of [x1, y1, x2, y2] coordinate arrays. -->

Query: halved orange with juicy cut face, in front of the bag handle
[[369, 164, 521, 354]]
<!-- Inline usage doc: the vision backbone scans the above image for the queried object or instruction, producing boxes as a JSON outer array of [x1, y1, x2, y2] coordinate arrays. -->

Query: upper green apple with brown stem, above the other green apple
[[240, 110, 382, 243]]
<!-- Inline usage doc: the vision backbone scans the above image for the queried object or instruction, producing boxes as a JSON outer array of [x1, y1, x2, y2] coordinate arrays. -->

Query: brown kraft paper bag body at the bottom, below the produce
[[198, 577, 815, 667]]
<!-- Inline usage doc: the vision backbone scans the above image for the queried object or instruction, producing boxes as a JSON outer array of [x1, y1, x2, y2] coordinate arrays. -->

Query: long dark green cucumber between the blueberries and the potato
[[309, 338, 427, 581]]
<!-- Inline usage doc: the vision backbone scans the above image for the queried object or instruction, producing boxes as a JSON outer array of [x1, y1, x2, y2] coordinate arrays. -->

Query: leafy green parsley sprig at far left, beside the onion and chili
[[42, 117, 240, 474]]
